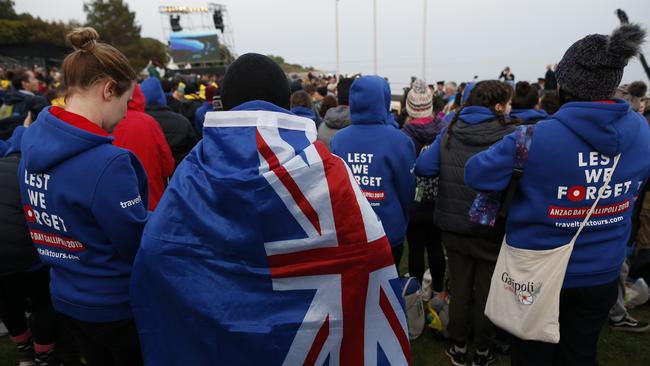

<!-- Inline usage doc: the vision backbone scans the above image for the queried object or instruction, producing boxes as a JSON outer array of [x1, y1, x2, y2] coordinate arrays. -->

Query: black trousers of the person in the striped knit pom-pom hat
[[406, 220, 445, 292]]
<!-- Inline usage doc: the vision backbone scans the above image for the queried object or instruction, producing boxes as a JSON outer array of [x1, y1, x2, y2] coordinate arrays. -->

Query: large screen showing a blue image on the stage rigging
[[169, 31, 221, 63]]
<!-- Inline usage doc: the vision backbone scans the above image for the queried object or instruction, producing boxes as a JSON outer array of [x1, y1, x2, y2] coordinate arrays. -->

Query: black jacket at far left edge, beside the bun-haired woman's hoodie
[[0, 153, 40, 276]]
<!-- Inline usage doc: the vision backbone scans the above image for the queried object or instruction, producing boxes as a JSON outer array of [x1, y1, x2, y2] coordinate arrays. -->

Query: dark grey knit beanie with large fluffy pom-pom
[[555, 24, 646, 100]]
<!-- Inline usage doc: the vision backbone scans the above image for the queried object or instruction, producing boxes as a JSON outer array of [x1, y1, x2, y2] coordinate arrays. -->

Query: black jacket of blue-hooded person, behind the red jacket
[[145, 105, 198, 166]]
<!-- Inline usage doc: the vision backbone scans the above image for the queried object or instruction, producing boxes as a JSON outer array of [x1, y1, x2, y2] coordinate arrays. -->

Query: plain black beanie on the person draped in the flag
[[221, 53, 290, 111]]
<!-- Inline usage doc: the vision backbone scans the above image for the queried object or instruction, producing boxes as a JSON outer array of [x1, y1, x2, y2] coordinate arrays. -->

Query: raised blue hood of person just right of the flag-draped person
[[350, 76, 390, 125]]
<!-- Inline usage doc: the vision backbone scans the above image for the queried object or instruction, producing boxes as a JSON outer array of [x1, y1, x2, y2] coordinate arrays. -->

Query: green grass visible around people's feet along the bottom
[[0, 244, 650, 366]]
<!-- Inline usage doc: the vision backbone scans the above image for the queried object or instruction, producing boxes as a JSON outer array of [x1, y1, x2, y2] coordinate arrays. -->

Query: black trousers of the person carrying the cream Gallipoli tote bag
[[511, 279, 618, 366]]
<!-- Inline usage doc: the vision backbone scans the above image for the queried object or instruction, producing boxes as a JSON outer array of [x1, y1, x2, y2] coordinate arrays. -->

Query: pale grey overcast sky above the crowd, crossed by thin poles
[[14, 0, 650, 89]]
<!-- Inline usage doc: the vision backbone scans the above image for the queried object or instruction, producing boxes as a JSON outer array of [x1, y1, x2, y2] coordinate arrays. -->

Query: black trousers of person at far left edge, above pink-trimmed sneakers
[[0, 267, 57, 345]]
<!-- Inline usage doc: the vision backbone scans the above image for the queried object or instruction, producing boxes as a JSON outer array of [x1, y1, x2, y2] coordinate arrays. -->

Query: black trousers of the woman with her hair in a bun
[[59, 313, 143, 366]]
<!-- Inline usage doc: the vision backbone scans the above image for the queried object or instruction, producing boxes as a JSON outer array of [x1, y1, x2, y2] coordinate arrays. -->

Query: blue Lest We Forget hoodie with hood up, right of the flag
[[331, 76, 415, 246]]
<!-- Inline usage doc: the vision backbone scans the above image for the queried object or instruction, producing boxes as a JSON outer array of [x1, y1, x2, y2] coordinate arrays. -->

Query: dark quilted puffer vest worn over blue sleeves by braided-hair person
[[434, 120, 515, 236]]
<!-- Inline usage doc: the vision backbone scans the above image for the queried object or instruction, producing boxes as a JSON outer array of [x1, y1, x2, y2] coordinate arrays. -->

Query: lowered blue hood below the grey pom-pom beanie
[[554, 99, 642, 156]]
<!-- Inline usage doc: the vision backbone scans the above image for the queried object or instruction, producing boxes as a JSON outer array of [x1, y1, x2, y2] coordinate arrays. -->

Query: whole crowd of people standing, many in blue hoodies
[[0, 20, 650, 366]]
